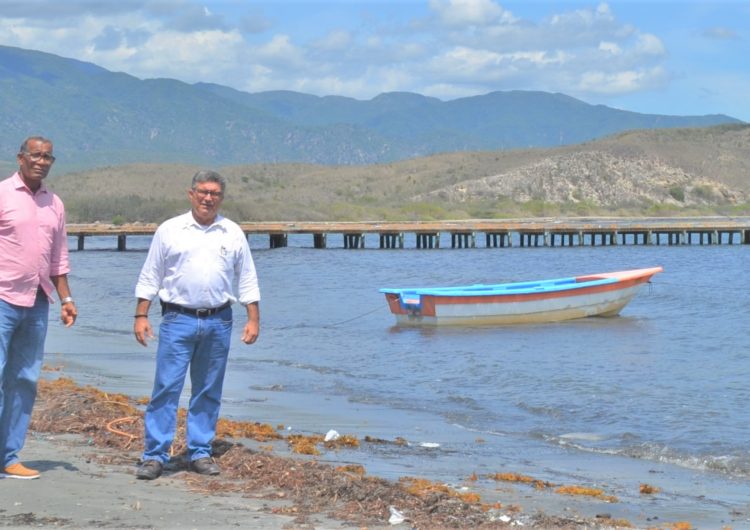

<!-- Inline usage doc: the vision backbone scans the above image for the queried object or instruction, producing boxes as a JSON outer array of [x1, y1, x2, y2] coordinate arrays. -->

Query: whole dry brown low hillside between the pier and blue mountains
[[49, 125, 750, 222]]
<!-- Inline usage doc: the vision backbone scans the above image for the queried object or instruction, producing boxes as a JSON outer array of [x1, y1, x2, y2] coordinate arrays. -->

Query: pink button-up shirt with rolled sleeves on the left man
[[0, 172, 70, 307]]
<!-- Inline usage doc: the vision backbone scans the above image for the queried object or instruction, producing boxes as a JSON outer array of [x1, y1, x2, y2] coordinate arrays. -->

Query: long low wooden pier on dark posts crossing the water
[[67, 217, 750, 250]]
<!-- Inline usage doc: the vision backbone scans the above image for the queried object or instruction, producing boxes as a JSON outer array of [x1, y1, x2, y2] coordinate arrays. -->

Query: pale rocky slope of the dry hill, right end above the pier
[[416, 126, 750, 210]]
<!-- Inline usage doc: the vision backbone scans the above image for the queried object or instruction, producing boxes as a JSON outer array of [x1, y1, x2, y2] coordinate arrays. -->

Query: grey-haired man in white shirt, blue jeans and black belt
[[133, 171, 260, 480]]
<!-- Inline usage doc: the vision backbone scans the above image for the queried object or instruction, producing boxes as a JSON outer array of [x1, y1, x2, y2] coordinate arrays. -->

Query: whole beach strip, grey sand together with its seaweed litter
[[0, 378, 739, 530]]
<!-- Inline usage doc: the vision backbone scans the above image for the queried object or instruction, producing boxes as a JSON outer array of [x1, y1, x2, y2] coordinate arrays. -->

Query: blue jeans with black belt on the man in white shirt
[[143, 307, 232, 463]]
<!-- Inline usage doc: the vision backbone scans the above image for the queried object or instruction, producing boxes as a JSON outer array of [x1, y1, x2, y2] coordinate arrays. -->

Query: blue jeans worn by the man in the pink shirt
[[0, 289, 49, 467]]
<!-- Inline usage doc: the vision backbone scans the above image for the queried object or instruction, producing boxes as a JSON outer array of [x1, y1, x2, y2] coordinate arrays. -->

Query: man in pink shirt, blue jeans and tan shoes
[[0, 136, 78, 479]]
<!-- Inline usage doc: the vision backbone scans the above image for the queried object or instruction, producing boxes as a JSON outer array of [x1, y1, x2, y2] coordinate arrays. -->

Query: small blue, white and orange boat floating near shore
[[381, 267, 662, 326]]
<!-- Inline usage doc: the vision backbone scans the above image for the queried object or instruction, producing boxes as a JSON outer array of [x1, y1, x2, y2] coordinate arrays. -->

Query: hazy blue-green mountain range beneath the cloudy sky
[[0, 46, 742, 173]]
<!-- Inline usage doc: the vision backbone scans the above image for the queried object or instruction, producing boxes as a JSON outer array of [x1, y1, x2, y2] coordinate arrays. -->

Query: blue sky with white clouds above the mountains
[[0, 0, 750, 122]]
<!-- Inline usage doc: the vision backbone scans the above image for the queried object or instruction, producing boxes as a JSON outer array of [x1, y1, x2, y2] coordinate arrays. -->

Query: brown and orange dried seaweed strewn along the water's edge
[[31, 378, 648, 529]]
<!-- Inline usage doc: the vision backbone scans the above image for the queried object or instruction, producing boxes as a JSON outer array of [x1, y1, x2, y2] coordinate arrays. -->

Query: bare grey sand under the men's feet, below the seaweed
[[0, 433, 318, 530]]
